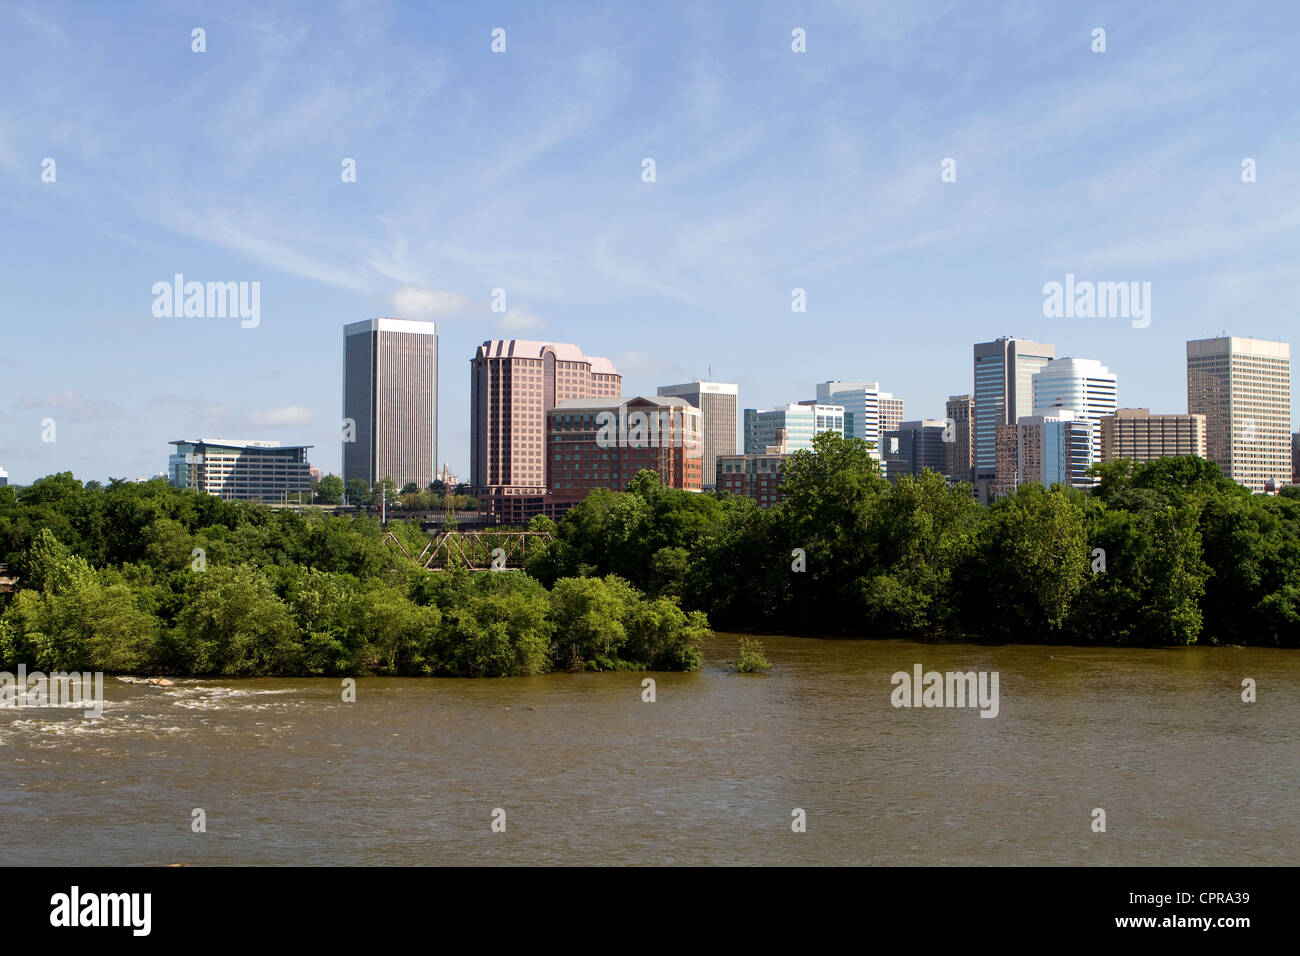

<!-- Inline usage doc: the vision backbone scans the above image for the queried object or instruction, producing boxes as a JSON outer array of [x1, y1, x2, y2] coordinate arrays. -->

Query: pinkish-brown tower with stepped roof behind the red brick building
[[469, 338, 623, 496]]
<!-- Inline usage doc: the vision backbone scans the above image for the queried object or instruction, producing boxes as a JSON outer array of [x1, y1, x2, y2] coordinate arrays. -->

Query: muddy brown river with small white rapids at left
[[0, 635, 1300, 866]]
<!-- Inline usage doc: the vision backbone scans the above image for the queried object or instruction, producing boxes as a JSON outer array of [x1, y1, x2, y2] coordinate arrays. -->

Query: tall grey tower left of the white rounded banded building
[[972, 336, 1056, 481]]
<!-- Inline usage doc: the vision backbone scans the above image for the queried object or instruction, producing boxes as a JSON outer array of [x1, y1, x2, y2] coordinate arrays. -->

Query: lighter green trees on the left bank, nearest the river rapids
[[0, 473, 709, 676]]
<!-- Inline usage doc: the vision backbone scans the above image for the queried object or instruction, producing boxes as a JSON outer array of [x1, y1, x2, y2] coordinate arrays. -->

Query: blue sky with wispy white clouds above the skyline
[[0, 0, 1300, 484]]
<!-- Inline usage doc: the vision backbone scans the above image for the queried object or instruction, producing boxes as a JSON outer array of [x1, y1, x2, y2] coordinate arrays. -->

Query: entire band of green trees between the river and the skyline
[[0, 434, 1300, 675]]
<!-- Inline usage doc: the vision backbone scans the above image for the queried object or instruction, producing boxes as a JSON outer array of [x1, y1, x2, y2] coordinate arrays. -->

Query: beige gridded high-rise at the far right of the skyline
[[1187, 336, 1291, 492]]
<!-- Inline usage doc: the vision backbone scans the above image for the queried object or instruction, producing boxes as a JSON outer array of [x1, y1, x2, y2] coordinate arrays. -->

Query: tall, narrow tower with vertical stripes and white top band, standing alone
[[343, 319, 438, 490]]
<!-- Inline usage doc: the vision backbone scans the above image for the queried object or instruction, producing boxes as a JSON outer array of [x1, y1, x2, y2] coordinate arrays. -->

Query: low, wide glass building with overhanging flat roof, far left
[[166, 438, 312, 503]]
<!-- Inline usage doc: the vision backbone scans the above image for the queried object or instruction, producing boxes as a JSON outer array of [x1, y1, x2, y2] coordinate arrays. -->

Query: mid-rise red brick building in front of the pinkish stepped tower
[[546, 395, 703, 502]]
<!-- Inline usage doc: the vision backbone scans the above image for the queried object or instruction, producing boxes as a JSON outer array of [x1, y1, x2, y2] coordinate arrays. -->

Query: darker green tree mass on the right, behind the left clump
[[529, 434, 1300, 646]]
